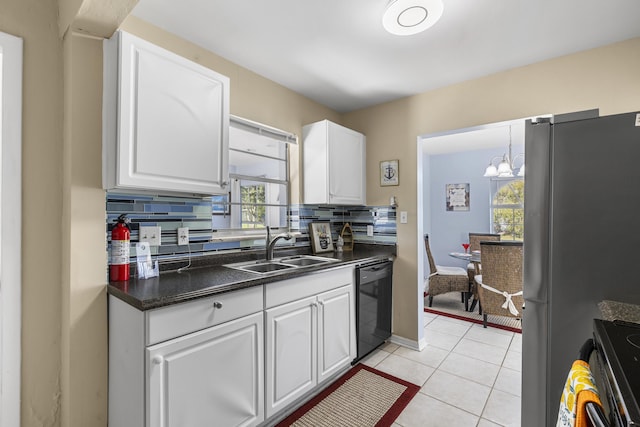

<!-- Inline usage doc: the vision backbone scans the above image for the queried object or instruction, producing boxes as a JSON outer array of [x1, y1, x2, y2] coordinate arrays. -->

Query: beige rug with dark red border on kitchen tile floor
[[277, 364, 420, 427]]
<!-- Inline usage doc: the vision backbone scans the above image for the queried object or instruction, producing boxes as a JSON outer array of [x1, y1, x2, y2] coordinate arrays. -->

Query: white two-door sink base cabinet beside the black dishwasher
[[265, 269, 355, 418]]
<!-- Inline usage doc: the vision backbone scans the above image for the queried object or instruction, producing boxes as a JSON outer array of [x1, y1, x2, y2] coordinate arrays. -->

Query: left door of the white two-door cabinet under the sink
[[265, 297, 317, 417]]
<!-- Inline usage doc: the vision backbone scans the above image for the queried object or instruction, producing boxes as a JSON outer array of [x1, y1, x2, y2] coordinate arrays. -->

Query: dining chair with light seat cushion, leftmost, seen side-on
[[424, 234, 469, 311]]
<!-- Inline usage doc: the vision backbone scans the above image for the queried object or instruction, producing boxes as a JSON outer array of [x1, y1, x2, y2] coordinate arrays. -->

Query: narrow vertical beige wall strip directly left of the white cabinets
[[60, 34, 108, 426]]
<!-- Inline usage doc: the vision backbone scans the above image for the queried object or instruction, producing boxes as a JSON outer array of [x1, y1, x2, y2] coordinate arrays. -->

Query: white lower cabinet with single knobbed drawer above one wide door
[[109, 286, 264, 427]]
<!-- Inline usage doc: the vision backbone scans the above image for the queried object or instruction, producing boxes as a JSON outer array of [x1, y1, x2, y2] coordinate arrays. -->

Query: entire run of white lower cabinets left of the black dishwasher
[[109, 267, 356, 427]]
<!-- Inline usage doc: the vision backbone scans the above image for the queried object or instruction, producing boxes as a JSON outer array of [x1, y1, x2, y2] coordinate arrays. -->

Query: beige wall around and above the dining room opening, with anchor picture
[[343, 38, 640, 340]]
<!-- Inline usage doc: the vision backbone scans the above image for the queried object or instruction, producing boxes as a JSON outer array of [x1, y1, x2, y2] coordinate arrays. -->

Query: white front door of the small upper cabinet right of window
[[328, 122, 366, 205]]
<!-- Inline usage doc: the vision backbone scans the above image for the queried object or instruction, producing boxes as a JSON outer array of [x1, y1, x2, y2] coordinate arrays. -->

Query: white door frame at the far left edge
[[0, 32, 22, 427]]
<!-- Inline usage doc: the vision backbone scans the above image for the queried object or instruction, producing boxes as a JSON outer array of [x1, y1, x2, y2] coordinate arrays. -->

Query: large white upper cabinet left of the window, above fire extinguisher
[[103, 31, 229, 195]]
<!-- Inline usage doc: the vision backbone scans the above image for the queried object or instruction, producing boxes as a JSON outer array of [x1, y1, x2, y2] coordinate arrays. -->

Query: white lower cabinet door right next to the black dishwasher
[[318, 285, 355, 382]]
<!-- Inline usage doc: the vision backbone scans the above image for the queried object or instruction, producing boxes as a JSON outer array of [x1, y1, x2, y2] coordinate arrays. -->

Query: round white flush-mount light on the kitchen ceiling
[[382, 0, 443, 36]]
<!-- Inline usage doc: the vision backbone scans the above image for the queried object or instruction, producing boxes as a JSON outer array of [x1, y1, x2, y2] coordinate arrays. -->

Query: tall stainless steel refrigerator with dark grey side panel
[[522, 110, 640, 427]]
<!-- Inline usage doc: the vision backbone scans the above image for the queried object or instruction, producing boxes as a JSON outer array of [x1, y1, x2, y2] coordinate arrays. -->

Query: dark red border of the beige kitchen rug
[[276, 363, 420, 427]]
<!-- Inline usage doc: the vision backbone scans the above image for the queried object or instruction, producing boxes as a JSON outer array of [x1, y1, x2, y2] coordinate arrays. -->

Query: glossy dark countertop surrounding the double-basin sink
[[107, 244, 396, 310]]
